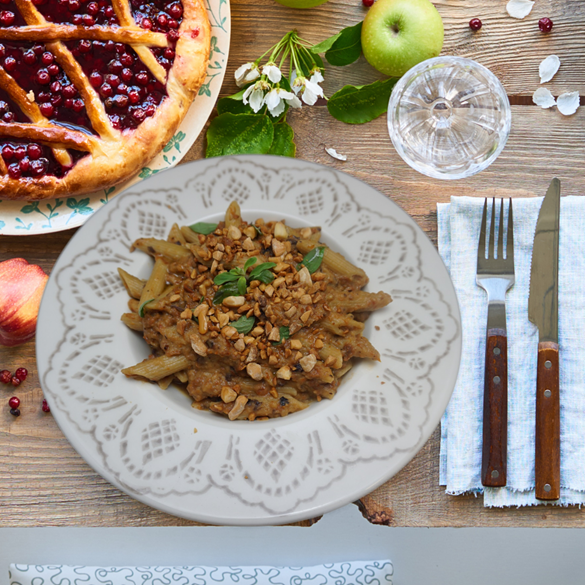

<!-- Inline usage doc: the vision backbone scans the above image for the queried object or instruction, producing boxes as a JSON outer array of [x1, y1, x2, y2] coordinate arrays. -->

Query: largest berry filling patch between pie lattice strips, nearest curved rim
[[72, 41, 167, 130]]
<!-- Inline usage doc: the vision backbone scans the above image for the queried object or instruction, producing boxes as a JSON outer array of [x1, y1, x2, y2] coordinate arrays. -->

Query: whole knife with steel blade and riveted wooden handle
[[528, 179, 561, 500]]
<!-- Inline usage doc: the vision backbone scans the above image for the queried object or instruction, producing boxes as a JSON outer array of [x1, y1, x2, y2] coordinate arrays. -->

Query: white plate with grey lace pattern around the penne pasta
[[37, 156, 461, 525]]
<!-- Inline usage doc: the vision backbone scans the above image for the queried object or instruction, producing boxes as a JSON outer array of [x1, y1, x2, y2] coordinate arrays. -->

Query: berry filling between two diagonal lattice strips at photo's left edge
[[0, 43, 93, 132]]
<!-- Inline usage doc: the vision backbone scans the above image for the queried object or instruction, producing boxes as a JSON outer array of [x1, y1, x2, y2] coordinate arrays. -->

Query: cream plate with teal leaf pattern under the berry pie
[[0, 0, 230, 236]]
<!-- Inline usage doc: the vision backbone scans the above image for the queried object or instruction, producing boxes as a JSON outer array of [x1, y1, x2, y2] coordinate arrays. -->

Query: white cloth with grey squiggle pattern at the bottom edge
[[9, 560, 394, 585]]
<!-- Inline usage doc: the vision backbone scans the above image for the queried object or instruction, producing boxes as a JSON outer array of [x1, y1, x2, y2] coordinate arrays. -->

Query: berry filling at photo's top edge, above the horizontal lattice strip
[[33, 0, 119, 26]]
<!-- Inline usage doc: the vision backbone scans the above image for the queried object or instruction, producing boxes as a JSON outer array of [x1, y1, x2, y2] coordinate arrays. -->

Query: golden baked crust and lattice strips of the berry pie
[[0, 0, 211, 201]]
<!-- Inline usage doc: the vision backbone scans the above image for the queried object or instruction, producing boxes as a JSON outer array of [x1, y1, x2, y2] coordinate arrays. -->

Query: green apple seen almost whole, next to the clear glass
[[362, 0, 444, 77]]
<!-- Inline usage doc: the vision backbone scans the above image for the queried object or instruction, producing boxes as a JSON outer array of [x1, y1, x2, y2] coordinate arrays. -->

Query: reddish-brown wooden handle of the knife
[[534, 341, 561, 500]]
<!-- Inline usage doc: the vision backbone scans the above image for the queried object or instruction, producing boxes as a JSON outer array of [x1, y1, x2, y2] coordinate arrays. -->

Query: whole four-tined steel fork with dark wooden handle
[[476, 199, 514, 487]]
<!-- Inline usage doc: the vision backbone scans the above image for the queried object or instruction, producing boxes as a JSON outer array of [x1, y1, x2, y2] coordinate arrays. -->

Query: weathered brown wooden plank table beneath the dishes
[[0, 0, 585, 527]]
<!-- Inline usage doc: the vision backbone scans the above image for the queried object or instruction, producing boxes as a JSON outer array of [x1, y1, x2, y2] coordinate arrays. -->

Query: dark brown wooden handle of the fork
[[481, 329, 508, 487]]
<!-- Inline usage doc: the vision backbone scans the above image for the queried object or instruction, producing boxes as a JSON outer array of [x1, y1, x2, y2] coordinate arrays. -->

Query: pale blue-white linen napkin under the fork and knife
[[437, 197, 585, 507]]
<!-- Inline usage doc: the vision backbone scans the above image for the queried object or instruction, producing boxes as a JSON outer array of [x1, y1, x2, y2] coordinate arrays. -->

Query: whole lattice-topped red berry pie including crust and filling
[[0, 0, 210, 200]]
